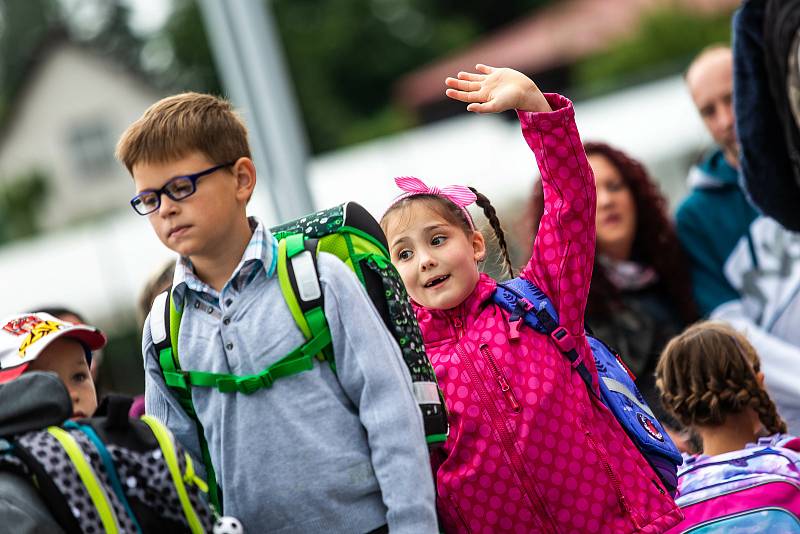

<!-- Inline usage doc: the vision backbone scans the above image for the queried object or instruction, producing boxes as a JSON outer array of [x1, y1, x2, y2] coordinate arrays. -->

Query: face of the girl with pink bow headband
[[386, 202, 486, 310]]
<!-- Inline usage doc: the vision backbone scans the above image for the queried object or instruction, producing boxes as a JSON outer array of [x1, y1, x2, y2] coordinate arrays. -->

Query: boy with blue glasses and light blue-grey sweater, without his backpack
[[117, 93, 436, 533]]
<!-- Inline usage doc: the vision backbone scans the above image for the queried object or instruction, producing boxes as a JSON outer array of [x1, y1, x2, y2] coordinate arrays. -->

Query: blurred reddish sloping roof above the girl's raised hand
[[395, 0, 740, 108]]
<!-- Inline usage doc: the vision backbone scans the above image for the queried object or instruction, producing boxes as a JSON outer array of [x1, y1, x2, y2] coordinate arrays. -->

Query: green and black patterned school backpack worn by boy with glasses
[[150, 202, 448, 513]]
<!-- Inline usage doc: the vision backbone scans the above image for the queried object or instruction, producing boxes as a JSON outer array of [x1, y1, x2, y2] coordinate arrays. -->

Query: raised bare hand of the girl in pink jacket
[[445, 63, 553, 113]]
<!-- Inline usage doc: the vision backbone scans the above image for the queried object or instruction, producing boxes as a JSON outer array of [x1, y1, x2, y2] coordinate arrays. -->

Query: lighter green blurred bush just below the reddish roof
[[573, 8, 731, 94]]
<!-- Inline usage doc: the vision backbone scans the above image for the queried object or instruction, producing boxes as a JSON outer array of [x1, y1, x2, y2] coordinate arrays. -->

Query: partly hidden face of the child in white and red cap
[[28, 338, 97, 419]]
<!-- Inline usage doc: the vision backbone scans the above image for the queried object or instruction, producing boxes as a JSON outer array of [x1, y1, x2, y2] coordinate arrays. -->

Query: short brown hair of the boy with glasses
[[116, 92, 250, 174]]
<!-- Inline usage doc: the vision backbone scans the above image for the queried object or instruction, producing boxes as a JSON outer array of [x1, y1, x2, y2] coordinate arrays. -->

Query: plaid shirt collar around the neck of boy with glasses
[[172, 217, 278, 306]]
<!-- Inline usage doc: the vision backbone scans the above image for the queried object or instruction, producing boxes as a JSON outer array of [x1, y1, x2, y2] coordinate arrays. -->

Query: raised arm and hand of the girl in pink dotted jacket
[[445, 65, 596, 335]]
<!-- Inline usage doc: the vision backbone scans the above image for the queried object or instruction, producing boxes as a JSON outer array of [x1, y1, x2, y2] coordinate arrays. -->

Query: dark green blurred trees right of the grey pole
[[274, 0, 477, 151]]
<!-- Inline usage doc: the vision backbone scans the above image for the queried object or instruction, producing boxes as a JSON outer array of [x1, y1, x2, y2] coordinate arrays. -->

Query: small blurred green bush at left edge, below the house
[[0, 170, 50, 243]]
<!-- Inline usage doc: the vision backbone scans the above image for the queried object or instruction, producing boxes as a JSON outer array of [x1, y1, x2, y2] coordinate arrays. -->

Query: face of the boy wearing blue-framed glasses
[[132, 152, 247, 258]]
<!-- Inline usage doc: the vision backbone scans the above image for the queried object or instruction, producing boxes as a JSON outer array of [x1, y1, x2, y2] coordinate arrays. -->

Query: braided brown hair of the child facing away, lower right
[[656, 321, 786, 434]]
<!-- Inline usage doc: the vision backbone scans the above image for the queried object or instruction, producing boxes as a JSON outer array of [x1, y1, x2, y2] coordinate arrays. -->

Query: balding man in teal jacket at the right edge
[[676, 46, 800, 434]]
